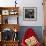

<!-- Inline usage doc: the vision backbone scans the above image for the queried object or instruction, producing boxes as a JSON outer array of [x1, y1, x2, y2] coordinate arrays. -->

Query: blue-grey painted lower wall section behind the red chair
[[19, 26, 43, 43]]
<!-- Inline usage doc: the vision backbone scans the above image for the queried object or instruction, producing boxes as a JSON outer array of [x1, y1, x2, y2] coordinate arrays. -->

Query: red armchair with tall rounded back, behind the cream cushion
[[21, 28, 41, 46]]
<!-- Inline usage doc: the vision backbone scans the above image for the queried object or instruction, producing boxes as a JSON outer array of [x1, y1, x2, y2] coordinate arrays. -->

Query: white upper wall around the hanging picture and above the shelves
[[0, 0, 44, 26]]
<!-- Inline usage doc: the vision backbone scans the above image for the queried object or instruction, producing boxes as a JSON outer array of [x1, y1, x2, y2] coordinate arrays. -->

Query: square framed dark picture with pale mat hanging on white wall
[[23, 7, 37, 21]]
